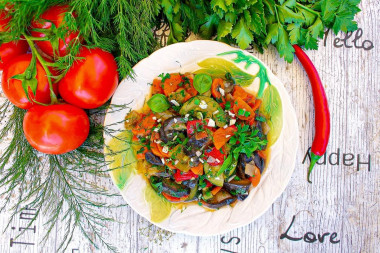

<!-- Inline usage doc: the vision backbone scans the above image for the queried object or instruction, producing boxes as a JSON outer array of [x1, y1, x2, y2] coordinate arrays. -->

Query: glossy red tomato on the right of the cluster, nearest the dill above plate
[[59, 47, 119, 109]]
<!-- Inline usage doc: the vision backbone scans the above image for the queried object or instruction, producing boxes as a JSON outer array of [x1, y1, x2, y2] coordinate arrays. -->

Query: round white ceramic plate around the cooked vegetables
[[104, 41, 298, 236]]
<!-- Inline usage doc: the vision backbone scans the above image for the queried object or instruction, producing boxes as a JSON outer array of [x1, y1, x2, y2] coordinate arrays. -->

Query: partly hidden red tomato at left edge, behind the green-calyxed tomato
[[0, 40, 29, 70]]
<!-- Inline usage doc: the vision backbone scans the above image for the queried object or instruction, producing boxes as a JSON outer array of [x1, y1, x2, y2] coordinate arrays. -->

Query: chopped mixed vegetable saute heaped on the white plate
[[125, 73, 269, 209]]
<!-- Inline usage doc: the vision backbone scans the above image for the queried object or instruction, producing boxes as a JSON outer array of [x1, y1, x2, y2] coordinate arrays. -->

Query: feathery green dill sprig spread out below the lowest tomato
[[0, 101, 129, 252]]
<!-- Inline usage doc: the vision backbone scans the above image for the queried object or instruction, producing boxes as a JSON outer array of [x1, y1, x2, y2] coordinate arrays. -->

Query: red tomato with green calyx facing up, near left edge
[[1, 54, 57, 109]]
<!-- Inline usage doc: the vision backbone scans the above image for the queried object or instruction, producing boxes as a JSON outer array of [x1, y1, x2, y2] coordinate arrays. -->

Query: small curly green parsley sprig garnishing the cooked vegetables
[[229, 124, 268, 159]]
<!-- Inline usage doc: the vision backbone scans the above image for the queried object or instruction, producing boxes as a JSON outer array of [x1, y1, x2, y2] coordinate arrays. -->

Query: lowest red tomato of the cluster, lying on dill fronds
[[23, 104, 90, 155]]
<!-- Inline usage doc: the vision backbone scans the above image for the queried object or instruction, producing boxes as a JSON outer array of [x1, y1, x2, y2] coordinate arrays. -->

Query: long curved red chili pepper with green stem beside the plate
[[293, 45, 330, 183]]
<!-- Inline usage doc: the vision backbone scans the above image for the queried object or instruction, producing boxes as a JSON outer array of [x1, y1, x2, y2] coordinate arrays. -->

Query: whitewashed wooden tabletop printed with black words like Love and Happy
[[0, 0, 380, 253]]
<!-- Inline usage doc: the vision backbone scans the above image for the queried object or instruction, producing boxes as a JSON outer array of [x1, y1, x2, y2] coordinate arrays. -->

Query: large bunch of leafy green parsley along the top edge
[[160, 0, 360, 62]]
